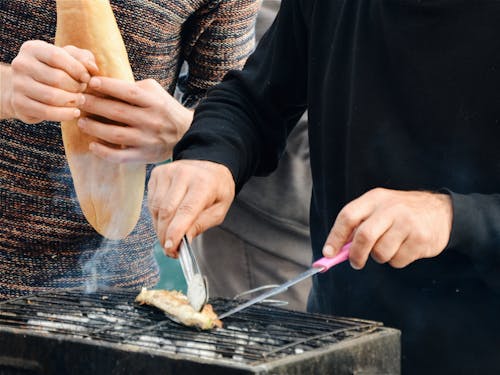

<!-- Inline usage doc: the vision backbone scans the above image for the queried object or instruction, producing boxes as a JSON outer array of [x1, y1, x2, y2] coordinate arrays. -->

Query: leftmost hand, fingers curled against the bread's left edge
[[1, 40, 98, 124]]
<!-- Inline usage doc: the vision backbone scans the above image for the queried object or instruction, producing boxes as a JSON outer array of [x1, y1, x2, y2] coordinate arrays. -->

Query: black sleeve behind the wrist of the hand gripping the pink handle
[[447, 192, 500, 291]]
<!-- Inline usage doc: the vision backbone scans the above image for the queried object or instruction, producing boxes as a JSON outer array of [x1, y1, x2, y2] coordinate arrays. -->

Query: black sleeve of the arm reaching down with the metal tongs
[[174, 0, 313, 191]]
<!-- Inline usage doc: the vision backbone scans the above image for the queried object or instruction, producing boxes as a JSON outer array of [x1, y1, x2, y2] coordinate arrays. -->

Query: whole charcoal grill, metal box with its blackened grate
[[0, 289, 400, 375]]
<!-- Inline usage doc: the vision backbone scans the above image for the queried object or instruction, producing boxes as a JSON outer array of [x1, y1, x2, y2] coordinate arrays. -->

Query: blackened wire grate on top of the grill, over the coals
[[0, 289, 382, 365]]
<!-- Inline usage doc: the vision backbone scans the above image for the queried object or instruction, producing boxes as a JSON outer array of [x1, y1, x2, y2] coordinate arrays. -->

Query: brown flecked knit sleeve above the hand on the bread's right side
[[179, 0, 261, 107]]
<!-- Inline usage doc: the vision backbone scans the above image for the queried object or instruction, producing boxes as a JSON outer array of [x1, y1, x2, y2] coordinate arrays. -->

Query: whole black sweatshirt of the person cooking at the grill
[[174, 0, 500, 374]]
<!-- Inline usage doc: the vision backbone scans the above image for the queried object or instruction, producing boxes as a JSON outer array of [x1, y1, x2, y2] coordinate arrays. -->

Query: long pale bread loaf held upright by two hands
[[55, 0, 146, 240]]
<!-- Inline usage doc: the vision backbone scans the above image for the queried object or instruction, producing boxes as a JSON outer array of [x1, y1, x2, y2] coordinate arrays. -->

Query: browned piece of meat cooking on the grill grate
[[135, 288, 222, 329]]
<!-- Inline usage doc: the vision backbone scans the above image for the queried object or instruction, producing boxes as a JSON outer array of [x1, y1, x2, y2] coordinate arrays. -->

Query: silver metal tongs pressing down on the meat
[[179, 235, 208, 311]]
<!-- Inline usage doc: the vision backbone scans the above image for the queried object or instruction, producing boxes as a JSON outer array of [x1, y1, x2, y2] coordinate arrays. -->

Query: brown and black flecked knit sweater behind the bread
[[0, 0, 260, 299]]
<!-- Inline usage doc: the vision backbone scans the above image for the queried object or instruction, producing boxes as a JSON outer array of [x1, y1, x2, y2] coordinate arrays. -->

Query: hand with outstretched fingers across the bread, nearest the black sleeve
[[78, 77, 193, 163]]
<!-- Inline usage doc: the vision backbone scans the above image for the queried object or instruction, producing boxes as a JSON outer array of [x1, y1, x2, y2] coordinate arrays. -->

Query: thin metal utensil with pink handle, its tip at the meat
[[219, 242, 351, 319]]
